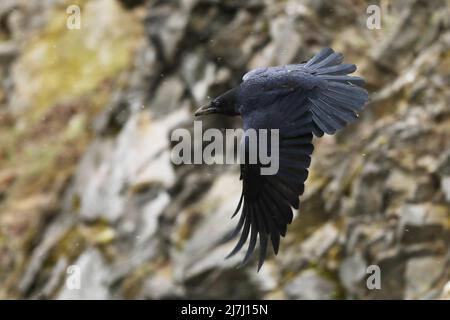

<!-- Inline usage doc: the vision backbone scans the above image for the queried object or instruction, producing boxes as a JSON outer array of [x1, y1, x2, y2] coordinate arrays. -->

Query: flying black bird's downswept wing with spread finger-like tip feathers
[[229, 90, 313, 270]]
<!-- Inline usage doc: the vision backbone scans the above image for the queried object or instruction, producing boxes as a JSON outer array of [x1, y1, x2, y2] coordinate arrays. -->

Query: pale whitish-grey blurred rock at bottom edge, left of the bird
[[57, 248, 110, 300]]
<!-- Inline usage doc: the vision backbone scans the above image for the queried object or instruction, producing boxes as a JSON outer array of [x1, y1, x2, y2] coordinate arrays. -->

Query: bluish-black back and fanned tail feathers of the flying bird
[[242, 48, 368, 137]]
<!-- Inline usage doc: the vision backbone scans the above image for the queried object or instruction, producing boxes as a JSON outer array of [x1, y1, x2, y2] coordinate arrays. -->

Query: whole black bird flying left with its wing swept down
[[195, 48, 368, 271]]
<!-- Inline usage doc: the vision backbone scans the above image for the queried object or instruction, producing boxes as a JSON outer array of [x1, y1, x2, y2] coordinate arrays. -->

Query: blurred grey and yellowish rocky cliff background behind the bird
[[0, 0, 450, 299]]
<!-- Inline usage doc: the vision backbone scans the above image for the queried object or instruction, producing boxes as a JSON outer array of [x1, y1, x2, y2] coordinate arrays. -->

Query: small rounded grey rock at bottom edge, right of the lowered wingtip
[[284, 269, 336, 300]]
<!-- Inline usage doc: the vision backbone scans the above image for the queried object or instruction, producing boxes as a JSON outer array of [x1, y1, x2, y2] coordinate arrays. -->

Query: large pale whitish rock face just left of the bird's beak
[[74, 109, 188, 222]]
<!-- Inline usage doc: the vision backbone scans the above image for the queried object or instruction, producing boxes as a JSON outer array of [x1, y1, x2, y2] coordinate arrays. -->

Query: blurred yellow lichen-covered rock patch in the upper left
[[9, 0, 143, 114]]
